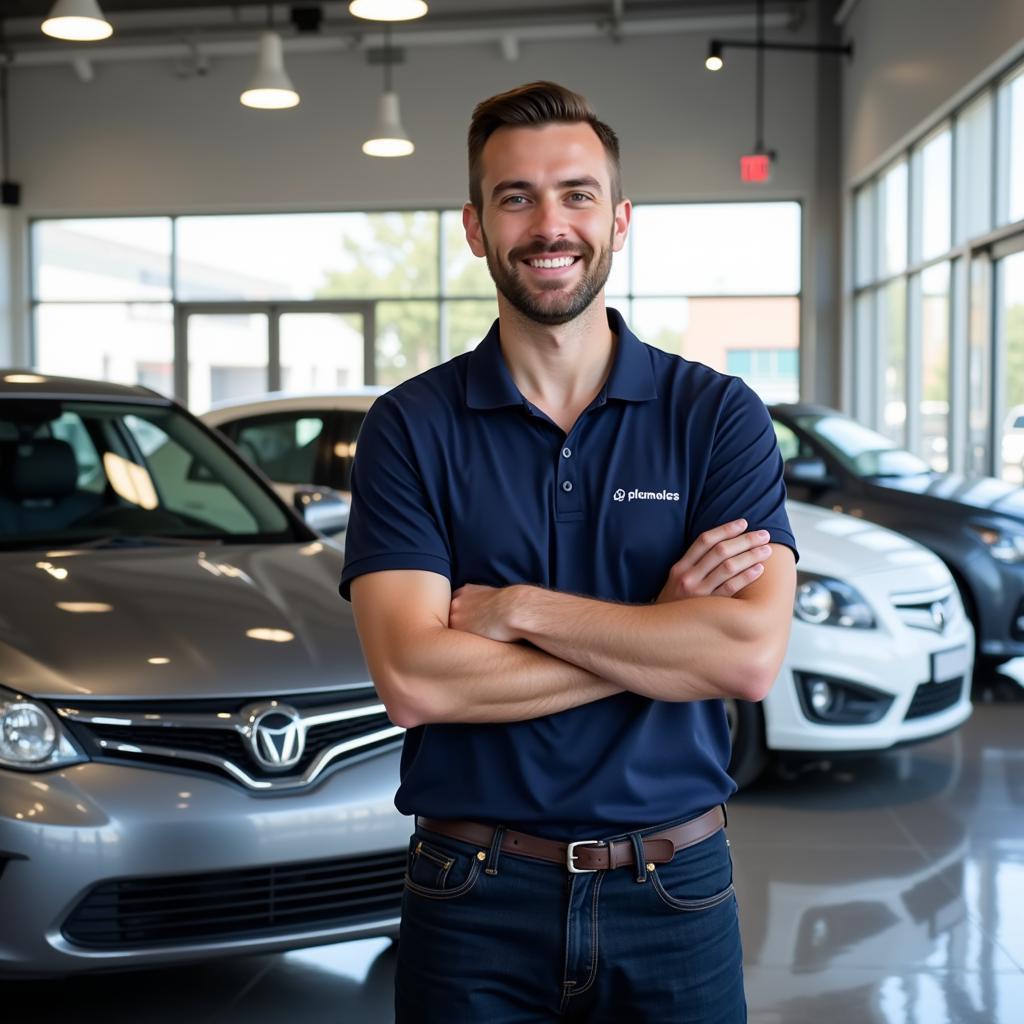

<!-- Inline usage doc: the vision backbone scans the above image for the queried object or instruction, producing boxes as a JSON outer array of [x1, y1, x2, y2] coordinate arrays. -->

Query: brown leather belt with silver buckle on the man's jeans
[[416, 807, 725, 874]]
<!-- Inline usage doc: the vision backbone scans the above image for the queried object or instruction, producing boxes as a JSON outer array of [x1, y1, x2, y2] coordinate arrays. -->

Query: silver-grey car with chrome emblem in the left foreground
[[0, 371, 411, 975]]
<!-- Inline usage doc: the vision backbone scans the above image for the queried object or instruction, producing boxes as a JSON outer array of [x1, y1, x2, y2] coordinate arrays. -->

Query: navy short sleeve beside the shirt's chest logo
[[690, 378, 800, 559]]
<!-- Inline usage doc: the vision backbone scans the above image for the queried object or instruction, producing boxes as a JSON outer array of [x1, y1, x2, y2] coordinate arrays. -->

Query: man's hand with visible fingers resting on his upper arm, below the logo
[[655, 519, 771, 604]]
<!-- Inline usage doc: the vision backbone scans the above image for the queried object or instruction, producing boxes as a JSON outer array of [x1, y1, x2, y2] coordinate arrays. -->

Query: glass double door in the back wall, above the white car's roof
[[174, 302, 375, 413]]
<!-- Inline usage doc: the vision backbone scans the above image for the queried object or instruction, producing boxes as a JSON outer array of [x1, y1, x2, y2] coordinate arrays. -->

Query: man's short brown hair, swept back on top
[[469, 82, 623, 210]]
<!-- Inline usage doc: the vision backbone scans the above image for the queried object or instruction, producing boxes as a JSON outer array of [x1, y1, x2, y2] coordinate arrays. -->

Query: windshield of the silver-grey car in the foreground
[[0, 398, 296, 548]]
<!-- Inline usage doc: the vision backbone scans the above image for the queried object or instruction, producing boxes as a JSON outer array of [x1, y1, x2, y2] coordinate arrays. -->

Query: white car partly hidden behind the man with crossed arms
[[202, 389, 975, 785]]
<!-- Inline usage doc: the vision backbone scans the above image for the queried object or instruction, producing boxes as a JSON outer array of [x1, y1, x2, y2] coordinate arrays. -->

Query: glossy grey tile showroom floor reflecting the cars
[[9, 663, 1024, 1024]]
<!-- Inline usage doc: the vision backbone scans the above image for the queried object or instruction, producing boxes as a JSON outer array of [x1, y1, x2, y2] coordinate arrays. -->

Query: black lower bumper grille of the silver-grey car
[[62, 850, 407, 949]]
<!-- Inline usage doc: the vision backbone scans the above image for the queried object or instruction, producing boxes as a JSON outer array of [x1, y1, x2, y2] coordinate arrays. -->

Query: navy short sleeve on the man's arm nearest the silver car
[[339, 396, 452, 601]]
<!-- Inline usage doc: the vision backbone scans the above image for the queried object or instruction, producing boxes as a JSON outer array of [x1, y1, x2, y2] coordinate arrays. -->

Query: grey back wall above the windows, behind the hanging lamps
[[0, 26, 817, 372]]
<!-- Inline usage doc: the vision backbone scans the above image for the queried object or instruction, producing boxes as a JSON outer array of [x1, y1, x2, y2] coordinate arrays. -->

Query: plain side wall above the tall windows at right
[[843, 0, 1024, 182]]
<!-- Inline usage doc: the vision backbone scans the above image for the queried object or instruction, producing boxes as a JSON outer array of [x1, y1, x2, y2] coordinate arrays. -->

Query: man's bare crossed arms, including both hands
[[351, 519, 796, 728]]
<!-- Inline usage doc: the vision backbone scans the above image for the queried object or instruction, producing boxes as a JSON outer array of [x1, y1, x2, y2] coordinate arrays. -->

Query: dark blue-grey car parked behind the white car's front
[[771, 404, 1024, 665]]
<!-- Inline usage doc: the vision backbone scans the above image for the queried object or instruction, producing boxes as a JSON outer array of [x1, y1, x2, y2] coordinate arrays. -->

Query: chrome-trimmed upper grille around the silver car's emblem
[[56, 687, 403, 792]]
